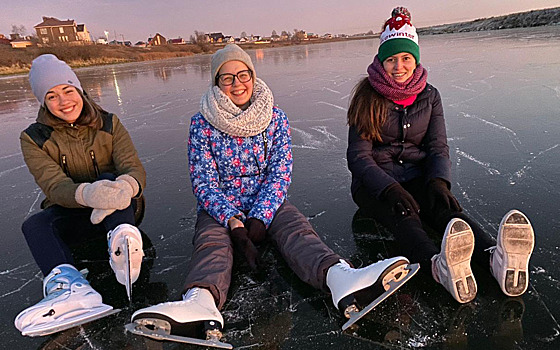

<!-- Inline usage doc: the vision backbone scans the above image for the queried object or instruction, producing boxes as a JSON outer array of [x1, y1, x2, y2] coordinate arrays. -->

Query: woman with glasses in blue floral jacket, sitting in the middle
[[127, 44, 413, 348]]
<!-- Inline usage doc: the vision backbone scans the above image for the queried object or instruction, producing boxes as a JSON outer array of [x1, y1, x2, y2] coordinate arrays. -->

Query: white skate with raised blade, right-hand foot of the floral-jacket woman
[[327, 256, 420, 331]]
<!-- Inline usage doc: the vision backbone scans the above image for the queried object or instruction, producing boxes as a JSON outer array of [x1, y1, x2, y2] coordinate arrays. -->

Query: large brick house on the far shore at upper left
[[33, 16, 91, 46]]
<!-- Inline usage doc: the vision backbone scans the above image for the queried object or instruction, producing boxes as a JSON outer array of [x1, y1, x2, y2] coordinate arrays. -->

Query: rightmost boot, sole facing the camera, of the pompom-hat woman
[[490, 210, 535, 297]]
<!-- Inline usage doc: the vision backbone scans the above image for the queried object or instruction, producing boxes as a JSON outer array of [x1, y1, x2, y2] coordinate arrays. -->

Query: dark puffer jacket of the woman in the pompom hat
[[346, 84, 451, 198]]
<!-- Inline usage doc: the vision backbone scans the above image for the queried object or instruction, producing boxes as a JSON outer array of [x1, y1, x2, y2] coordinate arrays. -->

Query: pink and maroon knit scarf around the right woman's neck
[[368, 55, 428, 101]]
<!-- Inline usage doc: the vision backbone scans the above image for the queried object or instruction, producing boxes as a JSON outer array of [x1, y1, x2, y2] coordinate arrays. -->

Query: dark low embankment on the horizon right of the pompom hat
[[417, 7, 560, 34]]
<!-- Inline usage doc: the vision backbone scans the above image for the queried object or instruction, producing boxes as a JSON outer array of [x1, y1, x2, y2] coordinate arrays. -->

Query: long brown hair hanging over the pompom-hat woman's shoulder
[[347, 78, 389, 142]]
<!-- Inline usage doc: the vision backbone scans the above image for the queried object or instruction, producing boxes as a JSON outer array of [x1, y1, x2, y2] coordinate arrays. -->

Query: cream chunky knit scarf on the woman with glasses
[[200, 78, 274, 137]]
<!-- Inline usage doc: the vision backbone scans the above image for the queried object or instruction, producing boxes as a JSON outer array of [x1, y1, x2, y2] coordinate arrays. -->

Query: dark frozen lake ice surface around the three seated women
[[0, 26, 560, 350]]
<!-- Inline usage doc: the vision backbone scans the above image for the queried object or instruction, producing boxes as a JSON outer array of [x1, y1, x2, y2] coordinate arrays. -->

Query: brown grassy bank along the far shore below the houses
[[0, 37, 371, 75]]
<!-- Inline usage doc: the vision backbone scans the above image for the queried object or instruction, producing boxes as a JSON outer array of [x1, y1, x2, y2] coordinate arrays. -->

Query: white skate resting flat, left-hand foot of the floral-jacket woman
[[125, 288, 233, 349]]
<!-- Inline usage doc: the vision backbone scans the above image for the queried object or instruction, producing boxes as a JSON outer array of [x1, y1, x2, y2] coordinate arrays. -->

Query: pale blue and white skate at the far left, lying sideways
[[14, 264, 120, 337]]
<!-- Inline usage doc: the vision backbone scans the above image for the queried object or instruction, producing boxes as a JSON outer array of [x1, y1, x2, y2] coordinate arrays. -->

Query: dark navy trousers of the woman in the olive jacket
[[21, 174, 136, 276]]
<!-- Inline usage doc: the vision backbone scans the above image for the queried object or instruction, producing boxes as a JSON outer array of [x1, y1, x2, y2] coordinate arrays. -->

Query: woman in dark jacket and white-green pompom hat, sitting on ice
[[347, 7, 535, 303]]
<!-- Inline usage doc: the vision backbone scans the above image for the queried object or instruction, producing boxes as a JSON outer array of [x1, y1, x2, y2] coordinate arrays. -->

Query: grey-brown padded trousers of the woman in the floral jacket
[[183, 201, 341, 309]]
